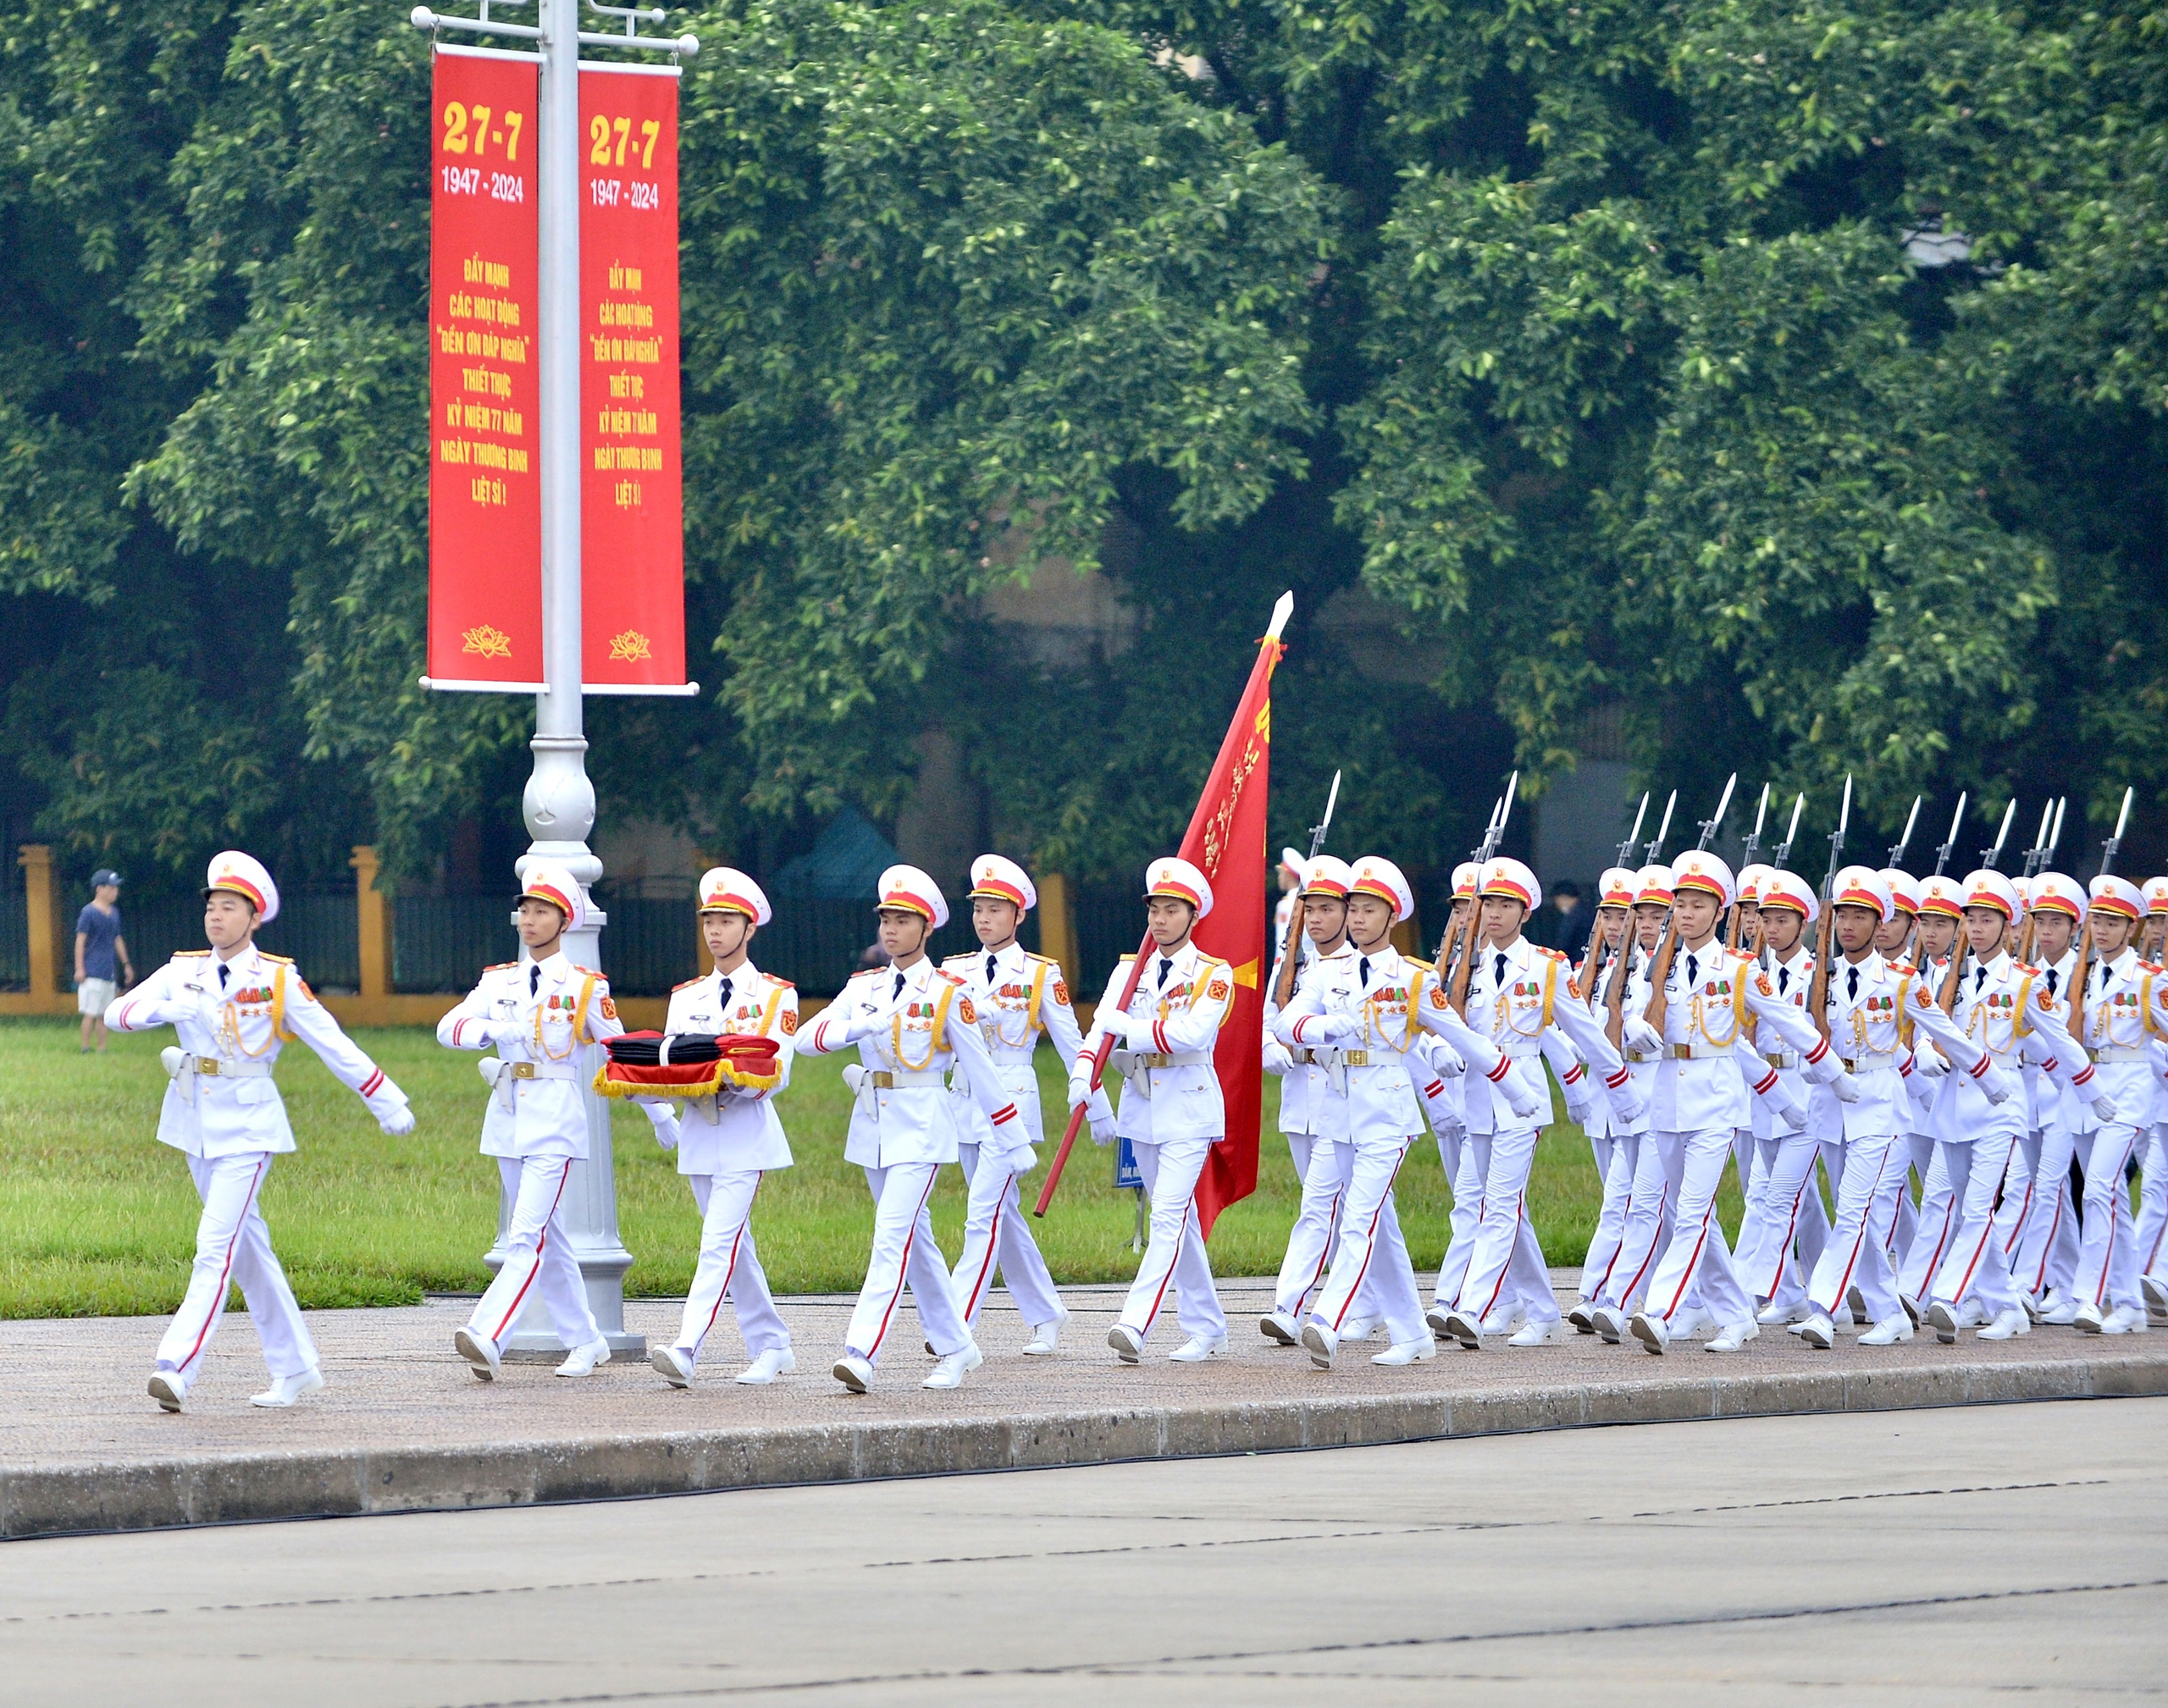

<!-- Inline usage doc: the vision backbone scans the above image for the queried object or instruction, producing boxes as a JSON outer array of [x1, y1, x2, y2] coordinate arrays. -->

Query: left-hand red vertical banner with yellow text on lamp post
[[429, 47, 542, 685]]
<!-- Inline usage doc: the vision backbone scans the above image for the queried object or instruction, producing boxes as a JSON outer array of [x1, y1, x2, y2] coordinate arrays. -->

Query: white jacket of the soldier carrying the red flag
[[1071, 942, 1234, 1144]]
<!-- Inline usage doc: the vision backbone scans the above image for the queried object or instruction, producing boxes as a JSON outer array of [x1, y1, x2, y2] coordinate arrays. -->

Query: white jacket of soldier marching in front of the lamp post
[[436, 949, 624, 1158]]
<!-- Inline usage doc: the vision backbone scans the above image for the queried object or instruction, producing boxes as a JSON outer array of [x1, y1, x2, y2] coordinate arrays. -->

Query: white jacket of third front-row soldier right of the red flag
[[1643, 938, 1839, 1134]]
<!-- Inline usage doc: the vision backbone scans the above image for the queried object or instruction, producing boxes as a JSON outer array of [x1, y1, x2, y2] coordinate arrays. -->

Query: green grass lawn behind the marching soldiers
[[0, 1019, 1647, 1318]]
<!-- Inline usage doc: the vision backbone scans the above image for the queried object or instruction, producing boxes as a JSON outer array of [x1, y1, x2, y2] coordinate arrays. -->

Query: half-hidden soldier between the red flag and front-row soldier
[[1258, 848, 1362, 1346]]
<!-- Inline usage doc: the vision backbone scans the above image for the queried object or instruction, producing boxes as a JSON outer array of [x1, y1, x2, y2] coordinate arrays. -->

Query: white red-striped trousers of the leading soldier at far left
[[158, 1151, 317, 1383]]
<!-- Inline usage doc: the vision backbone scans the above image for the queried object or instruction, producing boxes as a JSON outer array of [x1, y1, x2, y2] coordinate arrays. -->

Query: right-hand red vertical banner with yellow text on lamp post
[[579, 65, 685, 689]]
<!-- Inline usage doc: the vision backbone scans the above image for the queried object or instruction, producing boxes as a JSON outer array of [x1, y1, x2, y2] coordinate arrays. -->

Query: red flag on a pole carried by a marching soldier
[[1181, 596, 1294, 1238]]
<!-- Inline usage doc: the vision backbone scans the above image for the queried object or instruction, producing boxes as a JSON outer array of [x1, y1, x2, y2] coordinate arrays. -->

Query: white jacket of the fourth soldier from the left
[[798, 956, 1030, 1169]]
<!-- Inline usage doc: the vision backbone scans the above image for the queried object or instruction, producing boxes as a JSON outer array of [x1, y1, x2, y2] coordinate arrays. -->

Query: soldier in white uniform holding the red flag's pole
[[1069, 859, 1234, 1363]]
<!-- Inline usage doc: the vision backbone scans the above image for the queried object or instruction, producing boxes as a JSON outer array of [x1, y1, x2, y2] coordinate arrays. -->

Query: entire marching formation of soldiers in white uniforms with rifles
[[106, 785, 2168, 1411]]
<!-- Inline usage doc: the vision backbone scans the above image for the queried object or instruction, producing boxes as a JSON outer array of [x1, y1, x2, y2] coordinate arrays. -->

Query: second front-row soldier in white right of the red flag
[[1422, 859, 1645, 1348]]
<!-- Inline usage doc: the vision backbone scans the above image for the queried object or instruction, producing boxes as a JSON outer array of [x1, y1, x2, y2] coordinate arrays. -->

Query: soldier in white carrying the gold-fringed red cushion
[[648, 865, 798, 1387]]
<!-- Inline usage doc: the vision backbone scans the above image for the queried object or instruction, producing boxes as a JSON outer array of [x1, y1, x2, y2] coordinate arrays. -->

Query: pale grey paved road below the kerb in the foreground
[[0, 1401, 2168, 1708]]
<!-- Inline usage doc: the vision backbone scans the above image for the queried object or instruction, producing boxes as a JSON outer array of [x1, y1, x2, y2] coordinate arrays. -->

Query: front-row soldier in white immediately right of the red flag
[[1275, 854, 1437, 1370]]
